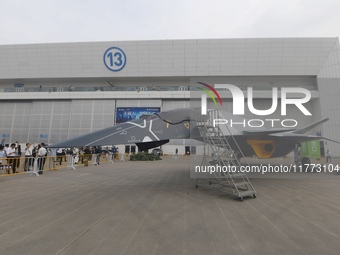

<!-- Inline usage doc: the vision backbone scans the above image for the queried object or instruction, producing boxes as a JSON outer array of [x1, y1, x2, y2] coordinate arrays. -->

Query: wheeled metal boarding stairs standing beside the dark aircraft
[[196, 110, 256, 201]]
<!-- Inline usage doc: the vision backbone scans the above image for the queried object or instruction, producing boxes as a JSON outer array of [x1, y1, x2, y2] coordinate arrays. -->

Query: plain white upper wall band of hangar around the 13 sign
[[0, 38, 337, 79]]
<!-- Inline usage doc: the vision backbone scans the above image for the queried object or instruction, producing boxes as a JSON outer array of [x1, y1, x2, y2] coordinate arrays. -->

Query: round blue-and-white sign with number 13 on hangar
[[103, 47, 126, 72]]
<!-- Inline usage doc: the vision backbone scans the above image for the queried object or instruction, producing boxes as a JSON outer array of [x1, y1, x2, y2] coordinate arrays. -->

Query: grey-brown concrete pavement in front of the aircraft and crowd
[[0, 158, 340, 255]]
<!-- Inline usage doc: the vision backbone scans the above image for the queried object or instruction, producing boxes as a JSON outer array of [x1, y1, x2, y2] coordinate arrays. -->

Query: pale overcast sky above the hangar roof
[[0, 0, 340, 45]]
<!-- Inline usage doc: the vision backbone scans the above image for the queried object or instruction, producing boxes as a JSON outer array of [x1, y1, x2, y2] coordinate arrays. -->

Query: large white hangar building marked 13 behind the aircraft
[[0, 38, 340, 156]]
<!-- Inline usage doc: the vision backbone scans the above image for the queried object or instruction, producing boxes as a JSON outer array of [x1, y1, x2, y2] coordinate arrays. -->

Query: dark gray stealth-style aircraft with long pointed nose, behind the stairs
[[50, 109, 337, 162]]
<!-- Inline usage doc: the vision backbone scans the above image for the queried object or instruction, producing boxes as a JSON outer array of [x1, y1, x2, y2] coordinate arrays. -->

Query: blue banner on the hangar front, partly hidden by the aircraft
[[116, 107, 161, 124]]
